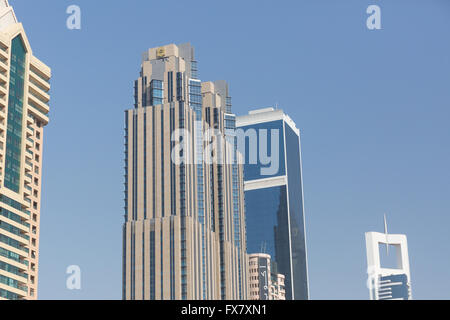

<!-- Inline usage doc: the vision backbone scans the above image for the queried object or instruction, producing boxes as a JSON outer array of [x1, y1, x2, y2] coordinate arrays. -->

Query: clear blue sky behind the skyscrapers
[[10, 0, 450, 299]]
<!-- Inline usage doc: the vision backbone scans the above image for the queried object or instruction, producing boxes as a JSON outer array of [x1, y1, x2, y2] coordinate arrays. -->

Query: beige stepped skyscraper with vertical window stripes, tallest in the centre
[[123, 44, 248, 300]]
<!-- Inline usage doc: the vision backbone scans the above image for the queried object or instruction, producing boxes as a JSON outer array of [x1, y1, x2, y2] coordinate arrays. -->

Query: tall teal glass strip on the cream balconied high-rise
[[5, 35, 26, 193]]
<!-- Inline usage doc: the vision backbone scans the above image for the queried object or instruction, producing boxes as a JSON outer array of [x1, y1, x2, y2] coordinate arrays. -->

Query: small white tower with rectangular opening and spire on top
[[366, 220, 412, 300]]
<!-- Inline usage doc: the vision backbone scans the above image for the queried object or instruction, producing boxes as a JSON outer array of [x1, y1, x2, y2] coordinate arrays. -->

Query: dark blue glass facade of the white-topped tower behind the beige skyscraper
[[241, 120, 308, 300]]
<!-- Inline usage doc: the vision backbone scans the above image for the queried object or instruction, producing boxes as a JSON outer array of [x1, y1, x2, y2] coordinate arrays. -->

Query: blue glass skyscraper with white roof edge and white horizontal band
[[236, 108, 309, 300]]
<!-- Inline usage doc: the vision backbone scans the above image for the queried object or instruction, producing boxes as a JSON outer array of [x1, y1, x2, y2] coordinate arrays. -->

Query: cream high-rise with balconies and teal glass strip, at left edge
[[0, 0, 51, 300]]
